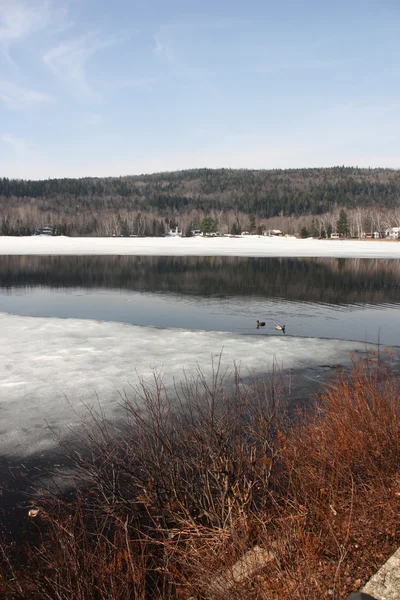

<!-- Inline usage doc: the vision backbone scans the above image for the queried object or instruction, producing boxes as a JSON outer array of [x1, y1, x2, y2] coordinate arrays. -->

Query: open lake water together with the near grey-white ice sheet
[[0, 255, 400, 457]]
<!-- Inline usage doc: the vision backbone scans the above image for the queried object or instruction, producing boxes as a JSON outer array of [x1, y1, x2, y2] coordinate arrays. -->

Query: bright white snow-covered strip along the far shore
[[0, 235, 400, 258]]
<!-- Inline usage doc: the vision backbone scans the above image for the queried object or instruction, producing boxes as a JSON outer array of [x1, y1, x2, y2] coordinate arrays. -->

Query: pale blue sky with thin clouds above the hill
[[0, 0, 400, 179]]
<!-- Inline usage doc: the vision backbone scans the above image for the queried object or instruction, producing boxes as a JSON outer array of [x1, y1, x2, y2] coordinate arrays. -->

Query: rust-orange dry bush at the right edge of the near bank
[[262, 352, 400, 598]]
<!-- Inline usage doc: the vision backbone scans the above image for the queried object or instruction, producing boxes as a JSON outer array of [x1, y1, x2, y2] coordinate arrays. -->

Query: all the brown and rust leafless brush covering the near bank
[[0, 355, 400, 600]]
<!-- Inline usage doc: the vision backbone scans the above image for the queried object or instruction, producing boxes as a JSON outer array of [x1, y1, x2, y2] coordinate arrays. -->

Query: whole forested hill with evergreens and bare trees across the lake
[[0, 167, 400, 235]]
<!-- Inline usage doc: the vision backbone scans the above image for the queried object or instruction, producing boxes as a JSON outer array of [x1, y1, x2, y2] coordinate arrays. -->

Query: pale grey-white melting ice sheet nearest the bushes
[[0, 313, 376, 456]]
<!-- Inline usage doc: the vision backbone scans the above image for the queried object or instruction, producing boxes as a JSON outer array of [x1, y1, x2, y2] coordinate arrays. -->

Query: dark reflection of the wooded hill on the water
[[0, 256, 400, 304]]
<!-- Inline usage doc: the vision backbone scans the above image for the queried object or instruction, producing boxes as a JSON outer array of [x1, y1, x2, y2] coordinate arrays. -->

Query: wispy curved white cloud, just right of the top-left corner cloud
[[43, 32, 120, 96]]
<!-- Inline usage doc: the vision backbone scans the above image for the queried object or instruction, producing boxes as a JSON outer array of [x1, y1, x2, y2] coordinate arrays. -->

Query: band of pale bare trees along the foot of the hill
[[0, 202, 400, 238]]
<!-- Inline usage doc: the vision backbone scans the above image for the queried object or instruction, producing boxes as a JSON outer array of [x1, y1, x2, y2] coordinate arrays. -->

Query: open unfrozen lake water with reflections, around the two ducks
[[0, 256, 400, 345]]
